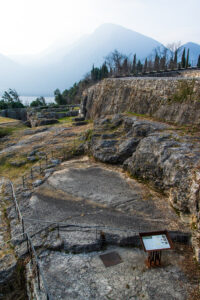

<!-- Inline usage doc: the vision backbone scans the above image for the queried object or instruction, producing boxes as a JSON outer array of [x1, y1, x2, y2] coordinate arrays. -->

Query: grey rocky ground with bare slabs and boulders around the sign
[[0, 115, 199, 300]]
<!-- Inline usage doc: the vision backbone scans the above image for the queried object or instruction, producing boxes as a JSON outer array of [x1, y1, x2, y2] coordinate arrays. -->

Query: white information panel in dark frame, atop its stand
[[140, 230, 173, 252]]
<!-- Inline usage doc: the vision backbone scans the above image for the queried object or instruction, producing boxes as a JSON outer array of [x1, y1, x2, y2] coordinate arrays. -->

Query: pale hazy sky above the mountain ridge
[[0, 0, 200, 54]]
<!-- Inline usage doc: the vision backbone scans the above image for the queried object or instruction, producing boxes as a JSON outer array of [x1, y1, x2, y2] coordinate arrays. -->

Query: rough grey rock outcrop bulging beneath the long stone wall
[[81, 115, 200, 260]]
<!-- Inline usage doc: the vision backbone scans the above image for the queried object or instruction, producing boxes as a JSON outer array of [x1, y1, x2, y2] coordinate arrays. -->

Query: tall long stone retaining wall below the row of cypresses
[[82, 77, 200, 125]]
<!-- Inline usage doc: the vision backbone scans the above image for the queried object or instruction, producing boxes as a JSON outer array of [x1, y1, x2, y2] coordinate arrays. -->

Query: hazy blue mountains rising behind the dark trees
[[0, 24, 200, 96]]
